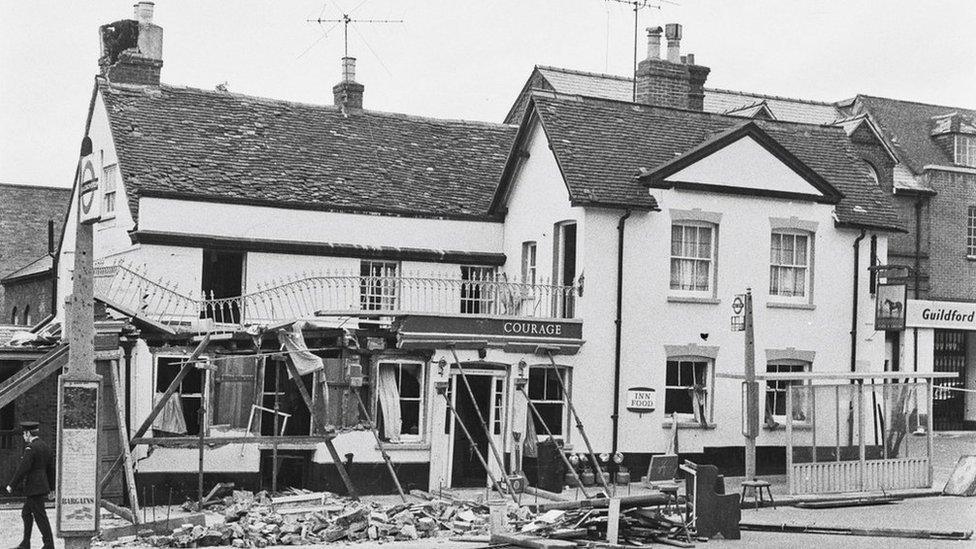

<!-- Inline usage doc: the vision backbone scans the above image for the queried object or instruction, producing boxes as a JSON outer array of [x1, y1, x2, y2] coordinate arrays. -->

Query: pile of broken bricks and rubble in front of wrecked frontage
[[143, 491, 516, 548]]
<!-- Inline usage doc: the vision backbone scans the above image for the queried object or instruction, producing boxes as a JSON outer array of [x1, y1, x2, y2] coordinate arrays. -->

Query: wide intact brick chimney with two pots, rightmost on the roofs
[[637, 23, 711, 111]]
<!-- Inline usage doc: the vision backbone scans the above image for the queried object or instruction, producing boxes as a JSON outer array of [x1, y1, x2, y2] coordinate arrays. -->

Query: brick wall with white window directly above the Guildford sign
[[928, 171, 976, 301]]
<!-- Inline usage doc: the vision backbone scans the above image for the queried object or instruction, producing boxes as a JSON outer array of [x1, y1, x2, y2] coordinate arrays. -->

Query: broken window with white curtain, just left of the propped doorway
[[376, 362, 425, 442]]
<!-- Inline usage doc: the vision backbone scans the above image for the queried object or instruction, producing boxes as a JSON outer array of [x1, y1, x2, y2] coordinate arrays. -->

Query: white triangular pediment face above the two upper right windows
[[664, 136, 824, 196]]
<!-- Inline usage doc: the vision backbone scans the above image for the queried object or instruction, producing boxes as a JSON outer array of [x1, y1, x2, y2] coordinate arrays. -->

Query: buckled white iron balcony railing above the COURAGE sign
[[95, 263, 576, 332]]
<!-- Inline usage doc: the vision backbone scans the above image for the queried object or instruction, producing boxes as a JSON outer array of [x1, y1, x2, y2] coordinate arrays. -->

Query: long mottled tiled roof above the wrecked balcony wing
[[99, 80, 516, 217]]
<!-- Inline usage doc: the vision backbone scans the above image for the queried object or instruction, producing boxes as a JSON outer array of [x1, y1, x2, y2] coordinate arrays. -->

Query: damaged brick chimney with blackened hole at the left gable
[[98, 2, 163, 86]]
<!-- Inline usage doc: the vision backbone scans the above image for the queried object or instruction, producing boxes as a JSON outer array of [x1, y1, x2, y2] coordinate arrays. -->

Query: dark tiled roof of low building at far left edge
[[0, 184, 71, 310]]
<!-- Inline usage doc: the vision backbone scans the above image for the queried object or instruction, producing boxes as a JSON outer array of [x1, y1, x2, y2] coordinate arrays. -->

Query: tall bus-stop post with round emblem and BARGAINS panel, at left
[[55, 137, 102, 549]]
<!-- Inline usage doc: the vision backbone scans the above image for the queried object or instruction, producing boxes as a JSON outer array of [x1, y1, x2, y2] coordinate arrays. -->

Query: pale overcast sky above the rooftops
[[0, 0, 976, 186]]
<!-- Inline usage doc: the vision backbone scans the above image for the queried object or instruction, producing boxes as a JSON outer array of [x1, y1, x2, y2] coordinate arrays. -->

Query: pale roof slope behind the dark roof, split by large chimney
[[513, 65, 840, 124]]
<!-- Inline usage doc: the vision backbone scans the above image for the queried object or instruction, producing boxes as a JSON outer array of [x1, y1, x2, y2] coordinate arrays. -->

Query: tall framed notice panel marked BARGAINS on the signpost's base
[[56, 374, 101, 536]]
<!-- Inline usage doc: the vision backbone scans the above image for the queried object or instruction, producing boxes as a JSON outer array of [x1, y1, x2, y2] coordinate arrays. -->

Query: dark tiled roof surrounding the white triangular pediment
[[533, 93, 903, 230]]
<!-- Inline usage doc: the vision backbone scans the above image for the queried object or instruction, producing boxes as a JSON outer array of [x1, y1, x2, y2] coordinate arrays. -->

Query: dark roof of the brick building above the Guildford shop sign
[[855, 95, 976, 174]]
